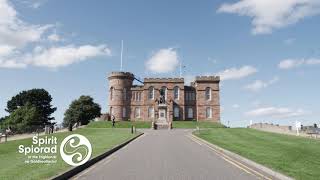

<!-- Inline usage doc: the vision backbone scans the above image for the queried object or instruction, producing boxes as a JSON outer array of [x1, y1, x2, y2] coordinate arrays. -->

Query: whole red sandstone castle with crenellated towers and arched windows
[[108, 72, 220, 123]]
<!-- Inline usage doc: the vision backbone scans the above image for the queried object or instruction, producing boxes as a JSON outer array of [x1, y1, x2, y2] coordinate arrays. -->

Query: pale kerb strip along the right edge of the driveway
[[191, 134, 293, 180]]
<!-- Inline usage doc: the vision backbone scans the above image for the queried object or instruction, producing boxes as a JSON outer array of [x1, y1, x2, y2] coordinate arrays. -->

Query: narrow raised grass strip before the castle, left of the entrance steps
[[87, 121, 151, 129]]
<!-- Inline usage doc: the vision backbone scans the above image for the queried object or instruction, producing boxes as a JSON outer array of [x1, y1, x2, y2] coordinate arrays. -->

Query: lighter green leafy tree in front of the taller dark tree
[[4, 103, 43, 133]]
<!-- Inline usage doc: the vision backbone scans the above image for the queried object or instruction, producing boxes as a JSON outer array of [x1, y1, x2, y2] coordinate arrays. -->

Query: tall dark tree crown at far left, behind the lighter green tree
[[6, 89, 57, 126]]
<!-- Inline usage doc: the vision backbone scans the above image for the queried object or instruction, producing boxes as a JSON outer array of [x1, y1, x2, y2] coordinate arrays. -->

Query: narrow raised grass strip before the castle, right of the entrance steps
[[172, 121, 225, 129]]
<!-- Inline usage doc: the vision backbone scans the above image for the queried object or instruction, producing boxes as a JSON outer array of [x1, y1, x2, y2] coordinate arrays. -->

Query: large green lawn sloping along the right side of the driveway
[[195, 128, 320, 180]]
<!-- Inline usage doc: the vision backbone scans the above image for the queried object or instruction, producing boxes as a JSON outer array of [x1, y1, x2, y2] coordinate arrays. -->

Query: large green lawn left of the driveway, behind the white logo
[[0, 128, 137, 180]]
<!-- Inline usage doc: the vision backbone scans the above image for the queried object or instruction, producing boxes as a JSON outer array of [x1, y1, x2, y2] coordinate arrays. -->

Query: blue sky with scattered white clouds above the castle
[[0, 0, 320, 127]]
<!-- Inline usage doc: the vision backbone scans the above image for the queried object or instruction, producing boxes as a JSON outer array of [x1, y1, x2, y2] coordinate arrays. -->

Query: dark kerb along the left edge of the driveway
[[51, 133, 144, 180]]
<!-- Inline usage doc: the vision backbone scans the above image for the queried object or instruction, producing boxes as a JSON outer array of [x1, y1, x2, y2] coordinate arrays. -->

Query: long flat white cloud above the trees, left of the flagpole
[[23, 45, 111, 68]]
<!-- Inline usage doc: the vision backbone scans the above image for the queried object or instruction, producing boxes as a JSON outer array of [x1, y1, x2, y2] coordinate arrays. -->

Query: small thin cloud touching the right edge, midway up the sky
[[278, 58, 320, 69]]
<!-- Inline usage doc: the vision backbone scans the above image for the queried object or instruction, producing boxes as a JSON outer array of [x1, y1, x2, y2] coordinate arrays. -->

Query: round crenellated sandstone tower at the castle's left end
[[108, 72, 134, 120]]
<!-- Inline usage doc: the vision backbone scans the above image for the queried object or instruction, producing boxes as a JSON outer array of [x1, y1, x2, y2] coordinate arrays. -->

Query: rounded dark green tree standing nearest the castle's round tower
[[63, 96, 101, 127]]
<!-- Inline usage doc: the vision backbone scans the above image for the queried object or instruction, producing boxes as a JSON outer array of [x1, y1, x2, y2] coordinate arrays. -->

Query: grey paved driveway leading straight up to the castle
[[74, 130, 259, 180]]
